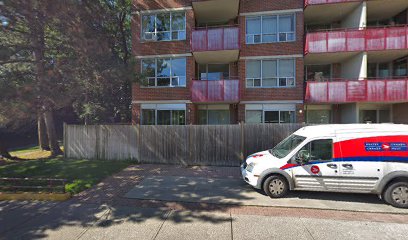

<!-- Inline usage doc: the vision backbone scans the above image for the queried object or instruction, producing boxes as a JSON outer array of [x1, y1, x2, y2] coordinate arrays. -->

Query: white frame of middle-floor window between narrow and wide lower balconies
[[245, 58, 296, 88]]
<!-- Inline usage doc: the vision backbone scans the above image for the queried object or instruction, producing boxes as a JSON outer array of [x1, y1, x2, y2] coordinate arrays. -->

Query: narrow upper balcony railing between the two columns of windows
[[191, 26, 240, 52]]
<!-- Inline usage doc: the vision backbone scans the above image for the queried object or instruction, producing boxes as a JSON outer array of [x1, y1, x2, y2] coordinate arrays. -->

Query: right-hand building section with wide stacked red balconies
[[304, 0, 408, 123]]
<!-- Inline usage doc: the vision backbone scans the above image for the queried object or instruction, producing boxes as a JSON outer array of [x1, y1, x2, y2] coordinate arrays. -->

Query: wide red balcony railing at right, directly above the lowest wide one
[[305, 26, 408, 54]]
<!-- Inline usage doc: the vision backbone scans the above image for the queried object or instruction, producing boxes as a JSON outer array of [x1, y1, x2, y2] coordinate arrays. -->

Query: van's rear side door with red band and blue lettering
[[337, 139, 389, 193]]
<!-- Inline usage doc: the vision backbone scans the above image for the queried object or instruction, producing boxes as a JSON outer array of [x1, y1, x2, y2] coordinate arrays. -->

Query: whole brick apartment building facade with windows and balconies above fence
[[132, 0, 408, 125]]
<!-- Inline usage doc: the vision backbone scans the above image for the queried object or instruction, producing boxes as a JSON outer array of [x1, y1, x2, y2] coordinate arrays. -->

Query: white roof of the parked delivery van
[[295, 123, 408, 137]]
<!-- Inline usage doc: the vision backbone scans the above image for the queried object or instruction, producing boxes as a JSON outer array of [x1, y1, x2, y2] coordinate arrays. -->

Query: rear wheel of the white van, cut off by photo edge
[[384, 182, 408, 208]]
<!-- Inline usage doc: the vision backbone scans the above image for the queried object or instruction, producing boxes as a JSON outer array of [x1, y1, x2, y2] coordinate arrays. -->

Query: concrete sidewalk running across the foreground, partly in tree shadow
[[0, 202, 408, 240]]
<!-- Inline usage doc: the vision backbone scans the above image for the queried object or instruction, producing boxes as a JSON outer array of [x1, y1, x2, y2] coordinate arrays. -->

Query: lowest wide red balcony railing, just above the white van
[[305, 78, 408, 103]]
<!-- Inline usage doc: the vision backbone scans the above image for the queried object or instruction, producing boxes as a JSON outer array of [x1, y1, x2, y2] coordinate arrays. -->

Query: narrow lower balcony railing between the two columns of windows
[[191, 80, 239, 102]]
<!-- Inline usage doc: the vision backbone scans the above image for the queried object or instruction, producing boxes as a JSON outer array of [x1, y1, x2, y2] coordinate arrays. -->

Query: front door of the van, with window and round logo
[[292, 138, 340, 191]]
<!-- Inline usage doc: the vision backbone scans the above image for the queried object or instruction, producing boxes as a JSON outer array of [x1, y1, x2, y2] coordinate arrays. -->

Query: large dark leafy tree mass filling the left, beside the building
[[0, 0, 133, 155]]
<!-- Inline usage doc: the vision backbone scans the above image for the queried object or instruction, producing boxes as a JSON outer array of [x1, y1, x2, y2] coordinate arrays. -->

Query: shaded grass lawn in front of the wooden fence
[[0, 158, 132, 194]]
